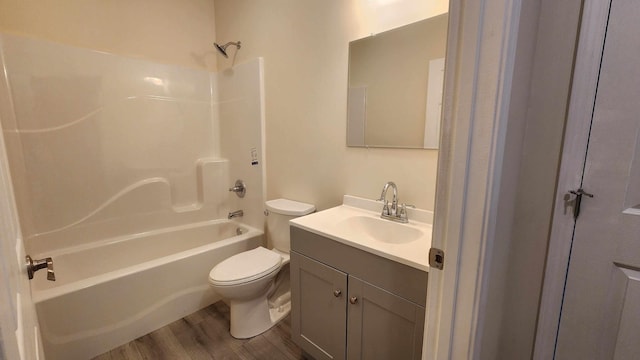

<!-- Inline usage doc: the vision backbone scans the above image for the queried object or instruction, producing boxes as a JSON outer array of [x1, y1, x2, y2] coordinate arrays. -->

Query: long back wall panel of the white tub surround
[[3, 35, 212, 248]]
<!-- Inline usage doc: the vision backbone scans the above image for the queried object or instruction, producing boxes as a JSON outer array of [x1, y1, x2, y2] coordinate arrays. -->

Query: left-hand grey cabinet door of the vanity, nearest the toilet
[[290, 251, 347, 360]]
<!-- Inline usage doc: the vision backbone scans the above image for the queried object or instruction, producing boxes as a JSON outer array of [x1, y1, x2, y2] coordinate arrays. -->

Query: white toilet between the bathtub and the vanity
[[209, 199, 315, 339]]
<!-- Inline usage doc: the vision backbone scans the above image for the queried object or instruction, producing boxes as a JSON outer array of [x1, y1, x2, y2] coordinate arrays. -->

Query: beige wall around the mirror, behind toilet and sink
[[215, 0, 448, 209]]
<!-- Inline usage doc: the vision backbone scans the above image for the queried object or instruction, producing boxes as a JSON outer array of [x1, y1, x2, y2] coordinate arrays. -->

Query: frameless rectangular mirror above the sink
[[347, 14, 448, 149]]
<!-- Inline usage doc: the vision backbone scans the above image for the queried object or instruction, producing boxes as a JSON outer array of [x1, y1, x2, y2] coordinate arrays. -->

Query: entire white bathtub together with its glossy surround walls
[[0, 34, 266, 359]]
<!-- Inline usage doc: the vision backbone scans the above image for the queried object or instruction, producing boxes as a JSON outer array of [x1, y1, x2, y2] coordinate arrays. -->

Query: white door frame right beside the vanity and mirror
[[423, 0, 537, 360]]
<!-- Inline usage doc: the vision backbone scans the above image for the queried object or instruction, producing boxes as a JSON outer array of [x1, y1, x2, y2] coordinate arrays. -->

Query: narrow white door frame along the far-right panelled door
[[533, 0, 611, 360]]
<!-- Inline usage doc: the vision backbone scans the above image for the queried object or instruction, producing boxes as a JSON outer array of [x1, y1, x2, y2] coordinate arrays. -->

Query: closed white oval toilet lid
[[209, 246, 282, 285]]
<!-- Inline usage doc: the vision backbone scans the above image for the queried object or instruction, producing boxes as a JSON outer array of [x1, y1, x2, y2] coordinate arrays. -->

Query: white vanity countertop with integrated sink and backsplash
[[290, 195, 433, 271]]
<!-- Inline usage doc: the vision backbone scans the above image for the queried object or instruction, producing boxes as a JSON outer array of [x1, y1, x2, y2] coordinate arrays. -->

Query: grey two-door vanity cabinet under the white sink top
[[291, 226, 427, 360]]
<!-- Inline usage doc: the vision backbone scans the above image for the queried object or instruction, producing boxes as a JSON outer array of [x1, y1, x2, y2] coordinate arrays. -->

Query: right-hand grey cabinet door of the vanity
[[347, 276, 425, 360]]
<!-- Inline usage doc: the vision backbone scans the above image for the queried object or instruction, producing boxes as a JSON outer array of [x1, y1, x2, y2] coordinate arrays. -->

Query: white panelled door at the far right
[[550, 0, 640, 359]]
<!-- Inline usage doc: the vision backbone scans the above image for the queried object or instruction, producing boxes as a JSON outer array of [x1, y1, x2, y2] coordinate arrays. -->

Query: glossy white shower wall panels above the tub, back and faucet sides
[[2, 34, 264, 250]]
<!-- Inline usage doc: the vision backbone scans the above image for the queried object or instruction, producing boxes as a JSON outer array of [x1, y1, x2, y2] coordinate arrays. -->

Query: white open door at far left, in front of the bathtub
[[0, 112, 41, 360]]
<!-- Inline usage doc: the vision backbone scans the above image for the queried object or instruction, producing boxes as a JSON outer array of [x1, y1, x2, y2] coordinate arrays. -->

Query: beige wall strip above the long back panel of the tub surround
[[0, 0, 217, 70]]
